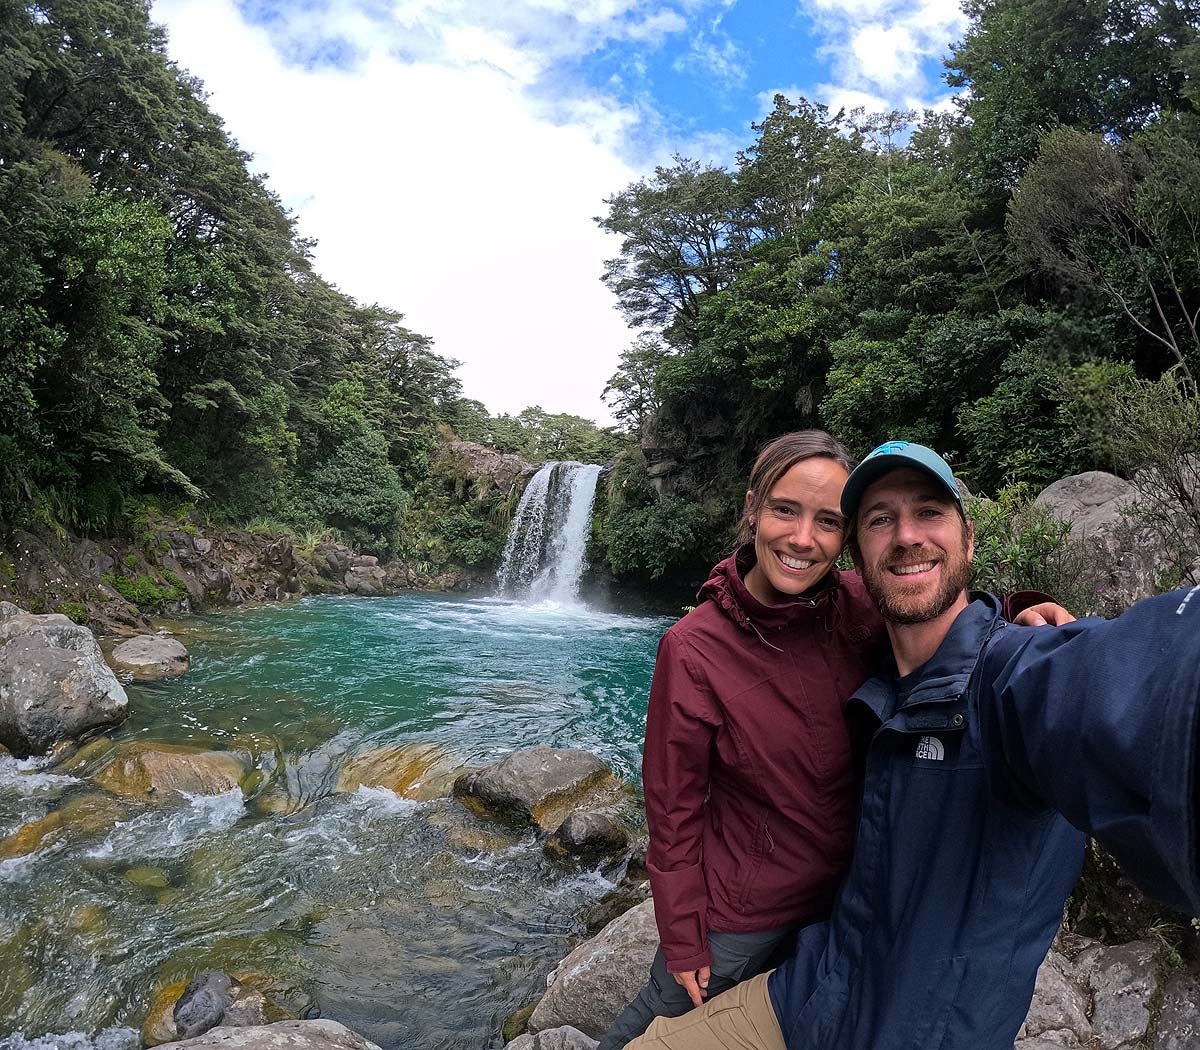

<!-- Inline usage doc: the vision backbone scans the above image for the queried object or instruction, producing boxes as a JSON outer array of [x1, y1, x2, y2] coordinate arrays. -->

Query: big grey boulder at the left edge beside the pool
[[0, 601, 128, 755]]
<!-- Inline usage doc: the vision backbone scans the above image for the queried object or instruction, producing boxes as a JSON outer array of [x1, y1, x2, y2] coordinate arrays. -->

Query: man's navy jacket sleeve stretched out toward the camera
[[977, 588, 1200, 914]]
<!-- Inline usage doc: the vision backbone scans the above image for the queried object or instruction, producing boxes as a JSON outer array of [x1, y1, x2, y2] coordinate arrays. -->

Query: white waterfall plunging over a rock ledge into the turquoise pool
[[497, 462, 600, 605]]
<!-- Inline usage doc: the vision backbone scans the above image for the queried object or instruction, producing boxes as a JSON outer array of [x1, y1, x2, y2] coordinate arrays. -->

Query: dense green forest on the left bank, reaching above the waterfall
[[0, 0, 618, 576]]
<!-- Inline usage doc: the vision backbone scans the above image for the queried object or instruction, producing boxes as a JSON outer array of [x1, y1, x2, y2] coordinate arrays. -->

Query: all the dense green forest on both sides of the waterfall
[[0, 0, 1200, 595]]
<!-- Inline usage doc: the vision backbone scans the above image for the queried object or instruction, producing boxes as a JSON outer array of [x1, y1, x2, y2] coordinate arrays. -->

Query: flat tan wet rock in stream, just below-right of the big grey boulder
[[94, 742, 246, 798]]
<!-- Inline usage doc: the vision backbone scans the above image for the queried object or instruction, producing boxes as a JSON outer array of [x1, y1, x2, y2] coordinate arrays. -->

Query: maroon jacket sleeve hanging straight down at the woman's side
[[642, 631, 716, 972]]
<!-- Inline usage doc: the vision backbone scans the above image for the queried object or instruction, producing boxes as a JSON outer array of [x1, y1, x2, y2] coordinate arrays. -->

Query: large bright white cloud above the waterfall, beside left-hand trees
[[147, 0, 696, 421]]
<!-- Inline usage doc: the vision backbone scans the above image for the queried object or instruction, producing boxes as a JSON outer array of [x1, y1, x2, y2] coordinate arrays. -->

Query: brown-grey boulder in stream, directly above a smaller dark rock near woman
[[454, 748, 619, 832]]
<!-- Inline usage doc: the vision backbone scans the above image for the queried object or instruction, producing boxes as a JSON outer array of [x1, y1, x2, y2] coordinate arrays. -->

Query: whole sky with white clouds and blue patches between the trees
[[152, 0, 965, 424]]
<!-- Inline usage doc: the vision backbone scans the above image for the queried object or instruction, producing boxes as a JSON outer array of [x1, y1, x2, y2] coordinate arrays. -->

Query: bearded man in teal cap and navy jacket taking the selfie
[[629, 442, 1200, 1050]]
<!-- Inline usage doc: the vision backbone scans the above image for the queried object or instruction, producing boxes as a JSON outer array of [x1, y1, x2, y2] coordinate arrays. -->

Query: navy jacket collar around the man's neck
[[853, 590, 1001, 722]]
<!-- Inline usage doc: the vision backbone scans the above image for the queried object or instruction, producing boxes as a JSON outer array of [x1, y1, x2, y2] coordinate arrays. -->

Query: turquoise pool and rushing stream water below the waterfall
[[0, 594, 671, 1050]]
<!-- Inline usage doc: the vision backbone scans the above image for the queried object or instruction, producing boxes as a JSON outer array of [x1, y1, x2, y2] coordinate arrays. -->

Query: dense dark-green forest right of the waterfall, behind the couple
[[598, 0, 1200, 588]]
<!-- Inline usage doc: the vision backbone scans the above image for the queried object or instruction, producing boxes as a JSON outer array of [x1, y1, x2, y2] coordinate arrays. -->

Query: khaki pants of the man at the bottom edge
[[625, 971, 787, 1050]]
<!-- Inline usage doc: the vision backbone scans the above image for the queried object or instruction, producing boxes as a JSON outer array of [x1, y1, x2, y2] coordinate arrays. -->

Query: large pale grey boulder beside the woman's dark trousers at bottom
[[529, 901, 659, 1039]]
